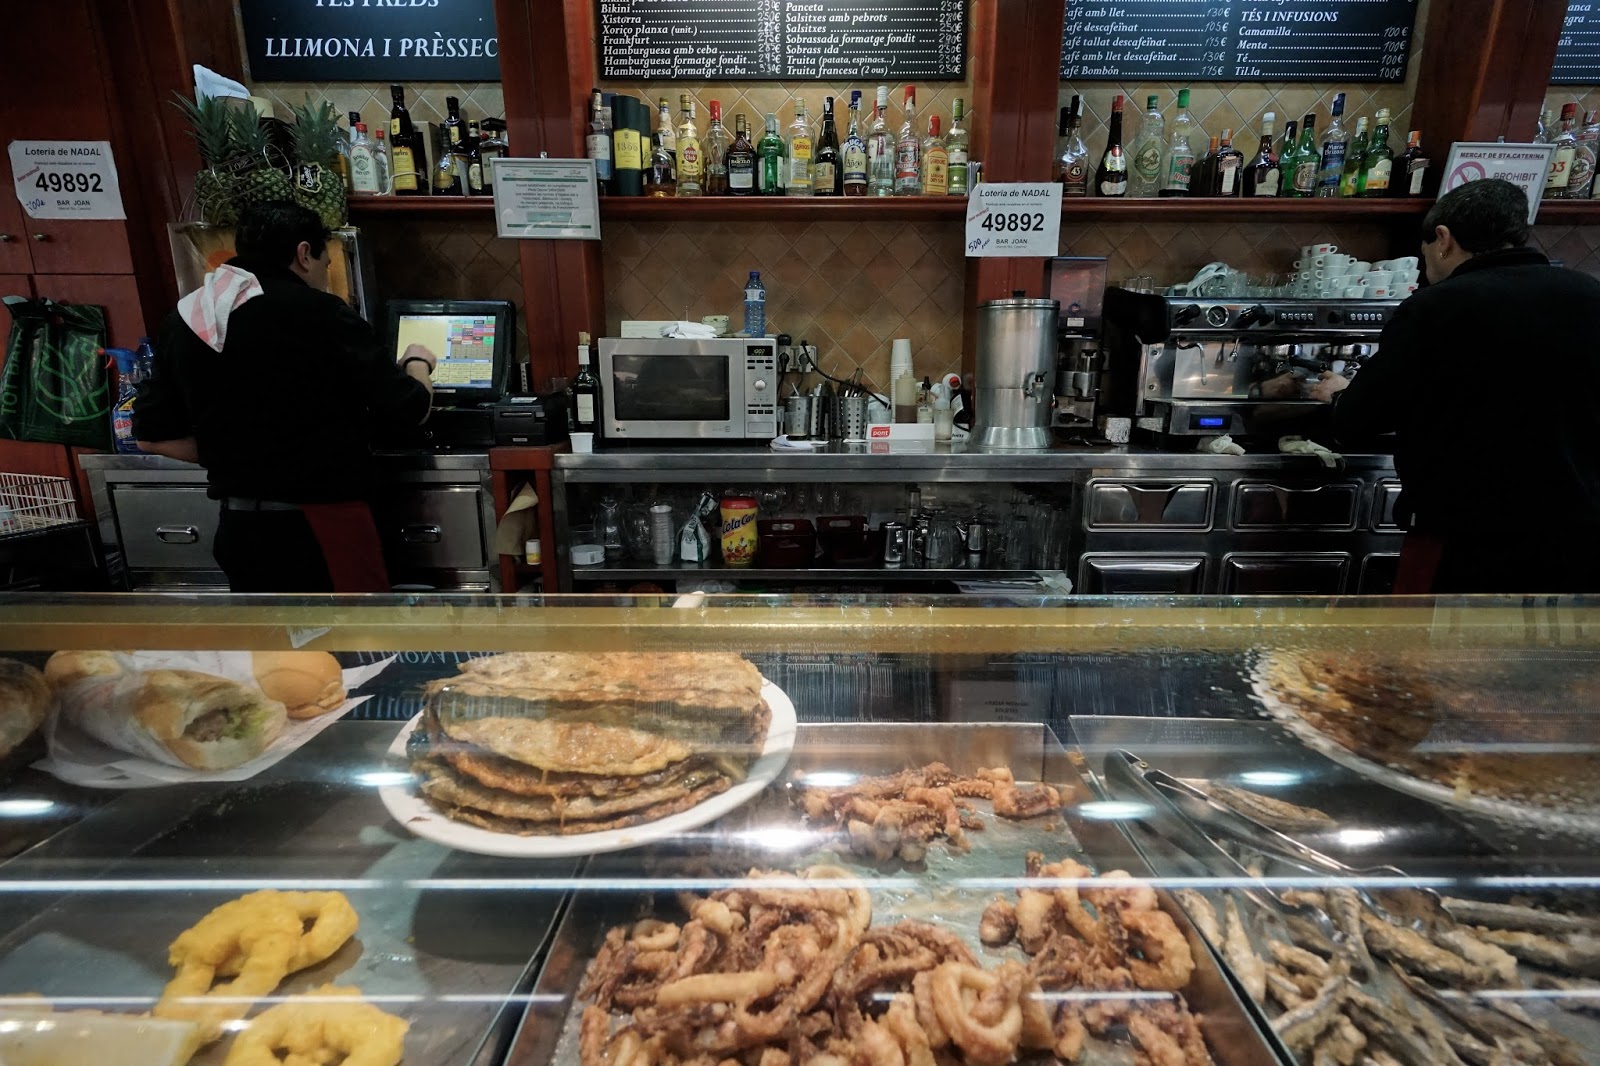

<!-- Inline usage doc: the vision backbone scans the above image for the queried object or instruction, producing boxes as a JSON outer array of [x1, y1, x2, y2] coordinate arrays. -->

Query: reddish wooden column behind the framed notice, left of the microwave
[[494, 0, 605, 389]]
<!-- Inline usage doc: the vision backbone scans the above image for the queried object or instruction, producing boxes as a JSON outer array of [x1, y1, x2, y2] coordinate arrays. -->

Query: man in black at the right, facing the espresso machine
[[1310, 179, 1600, 594]]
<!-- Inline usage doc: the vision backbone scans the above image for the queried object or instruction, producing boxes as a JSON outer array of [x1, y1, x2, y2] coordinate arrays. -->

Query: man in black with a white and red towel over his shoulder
[[133, 202, 435, 592]]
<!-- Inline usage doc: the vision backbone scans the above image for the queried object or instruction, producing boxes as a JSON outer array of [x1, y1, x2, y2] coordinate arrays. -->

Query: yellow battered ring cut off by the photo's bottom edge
[[222, 986, 411, 1066]]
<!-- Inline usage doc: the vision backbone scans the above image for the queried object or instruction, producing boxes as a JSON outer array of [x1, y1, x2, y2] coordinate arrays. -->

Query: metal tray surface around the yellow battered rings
[[0, 722, 578, 1066]]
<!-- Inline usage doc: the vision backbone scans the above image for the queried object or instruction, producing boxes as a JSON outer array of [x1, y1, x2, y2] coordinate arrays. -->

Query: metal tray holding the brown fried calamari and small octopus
[[507, 723, 1278, 1066]]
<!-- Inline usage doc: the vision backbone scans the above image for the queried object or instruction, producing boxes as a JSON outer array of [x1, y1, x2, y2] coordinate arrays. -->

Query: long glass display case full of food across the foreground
[[0, 594, 1600, 1066]]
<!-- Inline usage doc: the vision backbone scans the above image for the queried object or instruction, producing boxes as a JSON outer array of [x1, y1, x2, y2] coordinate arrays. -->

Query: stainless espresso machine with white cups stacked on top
[[1102, 288, 1398, 437]]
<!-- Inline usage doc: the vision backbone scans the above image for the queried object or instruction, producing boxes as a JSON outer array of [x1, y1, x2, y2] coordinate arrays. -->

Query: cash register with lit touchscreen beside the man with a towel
[[386, 299, 566, 451]]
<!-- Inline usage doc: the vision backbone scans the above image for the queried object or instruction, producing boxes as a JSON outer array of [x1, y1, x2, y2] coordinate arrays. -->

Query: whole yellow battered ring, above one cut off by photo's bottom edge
[[152, 893, 301, 1044]]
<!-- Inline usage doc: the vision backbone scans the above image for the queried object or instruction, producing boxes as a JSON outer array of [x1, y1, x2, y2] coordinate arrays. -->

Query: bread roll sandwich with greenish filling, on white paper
[[45, 651, 288, 770]]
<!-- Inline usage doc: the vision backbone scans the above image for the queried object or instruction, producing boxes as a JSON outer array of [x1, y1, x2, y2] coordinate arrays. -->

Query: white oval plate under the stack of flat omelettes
[[378, 679, 795, 858]]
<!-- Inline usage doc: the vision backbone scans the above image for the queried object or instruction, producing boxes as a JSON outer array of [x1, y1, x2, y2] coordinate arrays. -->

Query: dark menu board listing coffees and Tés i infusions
[[1061, 0, 1414, 82]]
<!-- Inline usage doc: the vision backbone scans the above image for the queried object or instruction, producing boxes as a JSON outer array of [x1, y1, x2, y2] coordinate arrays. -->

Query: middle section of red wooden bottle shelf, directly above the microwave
[[600, 197, 966, 222]]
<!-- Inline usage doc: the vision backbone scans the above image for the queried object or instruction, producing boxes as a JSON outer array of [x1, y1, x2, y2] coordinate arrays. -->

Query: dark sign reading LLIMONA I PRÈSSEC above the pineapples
[[238, 0, 499, 83]]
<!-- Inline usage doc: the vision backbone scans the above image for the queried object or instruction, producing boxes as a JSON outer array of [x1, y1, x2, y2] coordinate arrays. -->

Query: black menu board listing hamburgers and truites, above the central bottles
[[595, 0, 966, 82]]
